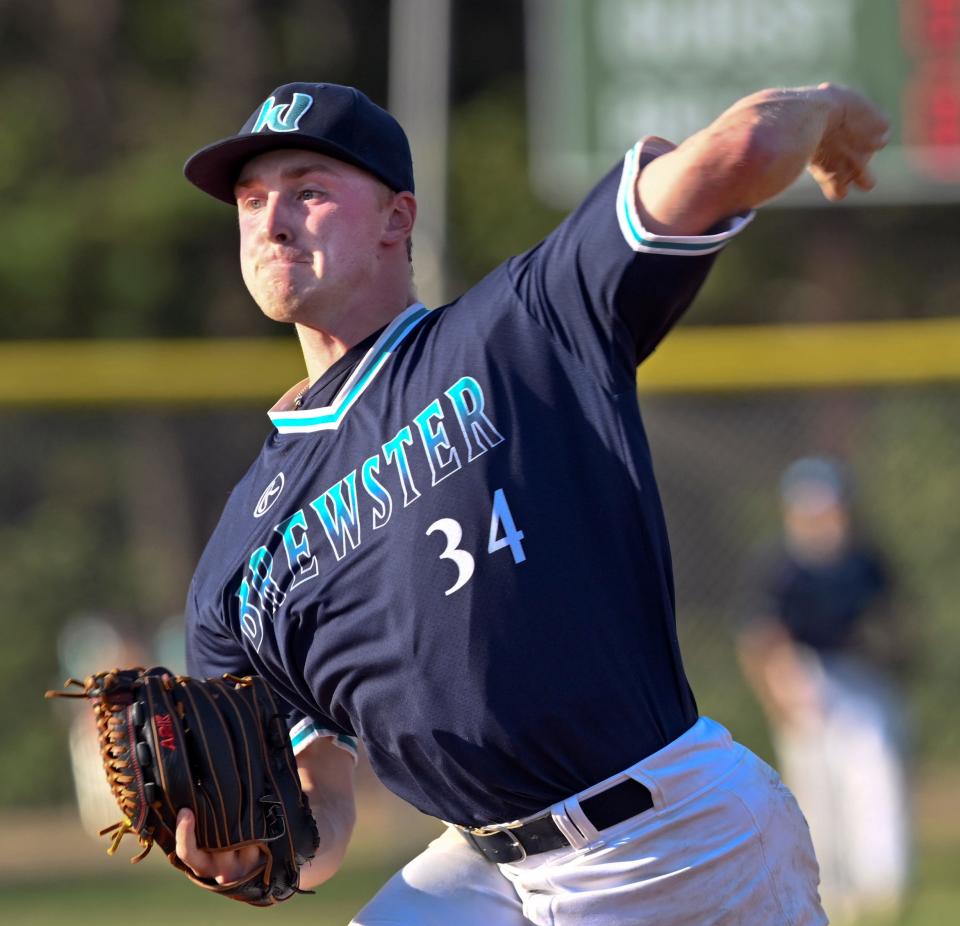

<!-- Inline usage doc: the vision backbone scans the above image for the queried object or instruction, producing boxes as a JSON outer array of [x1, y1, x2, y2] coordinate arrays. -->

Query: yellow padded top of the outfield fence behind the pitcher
[[0, 318, 960, 406]]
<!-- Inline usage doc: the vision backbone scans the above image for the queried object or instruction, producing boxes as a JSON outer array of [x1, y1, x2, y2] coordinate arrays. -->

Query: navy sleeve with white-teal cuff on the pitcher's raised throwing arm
[[507, 137, 753, 392]]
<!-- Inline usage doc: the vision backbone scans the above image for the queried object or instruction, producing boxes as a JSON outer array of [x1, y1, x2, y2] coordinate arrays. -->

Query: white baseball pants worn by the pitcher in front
[[353, 717, 827, 926]]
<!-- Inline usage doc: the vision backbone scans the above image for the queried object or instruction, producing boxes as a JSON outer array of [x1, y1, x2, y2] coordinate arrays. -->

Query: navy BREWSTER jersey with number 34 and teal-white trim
[[188, 140, 744, 824]]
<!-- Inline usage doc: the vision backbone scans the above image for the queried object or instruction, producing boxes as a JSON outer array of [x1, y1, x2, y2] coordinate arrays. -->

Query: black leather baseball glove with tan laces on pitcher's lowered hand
[[47, 668, 319, 906]]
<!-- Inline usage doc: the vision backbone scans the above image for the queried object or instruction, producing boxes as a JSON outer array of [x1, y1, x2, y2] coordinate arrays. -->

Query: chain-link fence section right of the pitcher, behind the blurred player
[[641, 386, 960, 761]]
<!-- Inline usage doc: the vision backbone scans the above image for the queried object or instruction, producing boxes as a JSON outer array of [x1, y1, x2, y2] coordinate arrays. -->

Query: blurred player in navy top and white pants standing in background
[[740, 458, 910, 923]]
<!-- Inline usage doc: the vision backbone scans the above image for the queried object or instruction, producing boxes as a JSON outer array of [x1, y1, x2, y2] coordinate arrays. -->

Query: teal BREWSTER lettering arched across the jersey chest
[[236, 376, 502, 652]]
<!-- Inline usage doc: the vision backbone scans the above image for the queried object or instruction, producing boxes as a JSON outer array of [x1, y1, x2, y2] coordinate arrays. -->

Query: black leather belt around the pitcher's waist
[[457, 778, 653, 863]]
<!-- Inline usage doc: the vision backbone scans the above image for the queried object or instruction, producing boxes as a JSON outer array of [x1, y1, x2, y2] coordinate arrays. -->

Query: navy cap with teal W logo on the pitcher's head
[[183, 83, 413, 205]]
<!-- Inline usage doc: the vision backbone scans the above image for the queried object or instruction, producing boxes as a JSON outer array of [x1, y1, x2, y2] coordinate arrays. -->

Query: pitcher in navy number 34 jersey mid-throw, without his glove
[[178, 83, 887, 926]]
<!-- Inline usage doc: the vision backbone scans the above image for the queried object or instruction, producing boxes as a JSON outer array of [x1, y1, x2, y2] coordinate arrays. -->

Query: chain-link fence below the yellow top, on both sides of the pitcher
[[0, 385, 960, 805]]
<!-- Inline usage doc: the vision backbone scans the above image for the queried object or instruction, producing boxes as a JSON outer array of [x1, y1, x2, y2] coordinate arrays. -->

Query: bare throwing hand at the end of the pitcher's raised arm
[[807, 84, 890, 201]]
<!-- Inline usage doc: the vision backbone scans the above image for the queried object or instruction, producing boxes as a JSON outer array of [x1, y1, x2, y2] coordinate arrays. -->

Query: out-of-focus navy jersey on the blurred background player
[[765, 546, 890, 653]]
